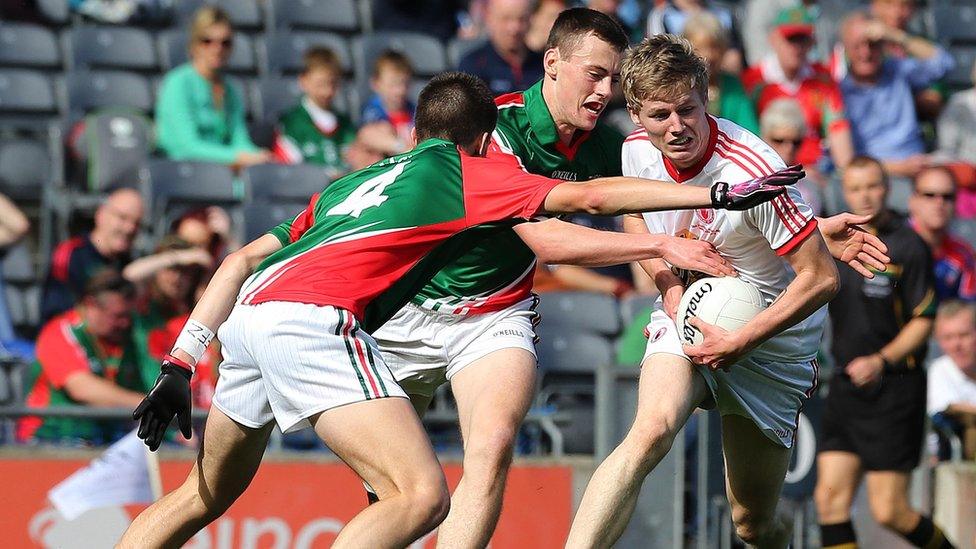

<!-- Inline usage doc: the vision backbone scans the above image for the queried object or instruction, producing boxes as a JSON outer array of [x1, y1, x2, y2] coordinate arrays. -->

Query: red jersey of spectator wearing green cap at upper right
[[742, 57, 849, 166]]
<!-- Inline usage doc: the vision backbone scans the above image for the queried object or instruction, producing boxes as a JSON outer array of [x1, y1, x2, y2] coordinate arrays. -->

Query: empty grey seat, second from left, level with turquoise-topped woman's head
[[68, 27, 159, 72]]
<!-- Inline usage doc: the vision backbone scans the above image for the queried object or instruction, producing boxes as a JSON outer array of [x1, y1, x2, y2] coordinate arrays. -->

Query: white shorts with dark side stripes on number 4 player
[[213, 301, 406, 433]]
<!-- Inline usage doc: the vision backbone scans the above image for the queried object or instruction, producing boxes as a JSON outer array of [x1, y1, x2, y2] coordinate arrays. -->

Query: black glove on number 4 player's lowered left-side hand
[[132, 355, 193, 452]]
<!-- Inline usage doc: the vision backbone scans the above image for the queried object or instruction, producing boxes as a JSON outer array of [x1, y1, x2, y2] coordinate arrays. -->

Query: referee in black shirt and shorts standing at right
[[815, 157, 952, 548]]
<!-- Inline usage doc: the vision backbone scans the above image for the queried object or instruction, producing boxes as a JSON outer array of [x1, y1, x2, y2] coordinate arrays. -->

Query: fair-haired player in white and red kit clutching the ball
[[567, 35, 852, 547]]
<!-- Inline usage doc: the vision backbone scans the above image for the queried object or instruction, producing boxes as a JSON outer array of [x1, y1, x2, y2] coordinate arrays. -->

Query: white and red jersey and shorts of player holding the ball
[[622, 116, 827, 447]]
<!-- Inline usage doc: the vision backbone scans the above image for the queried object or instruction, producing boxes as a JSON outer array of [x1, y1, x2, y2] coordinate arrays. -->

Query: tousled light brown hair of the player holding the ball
[[620, 34, 708, 112]]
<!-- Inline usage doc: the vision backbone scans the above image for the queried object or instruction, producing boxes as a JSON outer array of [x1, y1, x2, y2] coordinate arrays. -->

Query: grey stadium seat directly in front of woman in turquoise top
[[140, 159, 243, 236]]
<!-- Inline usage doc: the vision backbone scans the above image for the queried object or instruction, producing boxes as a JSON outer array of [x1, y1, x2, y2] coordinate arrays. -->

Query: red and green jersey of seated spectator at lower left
[[17, 309, 149, 444]]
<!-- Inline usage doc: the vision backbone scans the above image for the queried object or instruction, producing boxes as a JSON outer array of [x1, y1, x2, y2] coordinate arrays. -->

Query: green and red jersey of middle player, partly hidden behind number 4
[[413, 82, 624, 314]]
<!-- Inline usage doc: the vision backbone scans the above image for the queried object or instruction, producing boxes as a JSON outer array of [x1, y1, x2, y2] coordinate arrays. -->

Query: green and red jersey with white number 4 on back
[[241, 139, 561, 332]]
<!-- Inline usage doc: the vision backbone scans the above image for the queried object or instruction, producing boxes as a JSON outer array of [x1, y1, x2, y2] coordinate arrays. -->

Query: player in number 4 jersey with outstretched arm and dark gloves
[[119, 73, 803, 548]]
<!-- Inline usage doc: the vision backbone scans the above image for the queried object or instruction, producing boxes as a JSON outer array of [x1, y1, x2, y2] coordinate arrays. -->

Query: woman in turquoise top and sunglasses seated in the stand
[[156, 6, 272, 169]]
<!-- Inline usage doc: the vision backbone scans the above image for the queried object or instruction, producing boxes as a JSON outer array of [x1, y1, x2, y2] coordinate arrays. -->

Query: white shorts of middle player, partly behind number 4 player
[[373, 296, 538, 397]]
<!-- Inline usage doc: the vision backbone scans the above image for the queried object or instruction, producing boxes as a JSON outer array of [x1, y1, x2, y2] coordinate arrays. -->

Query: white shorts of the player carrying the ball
[[644, 308, 818, 448]]
